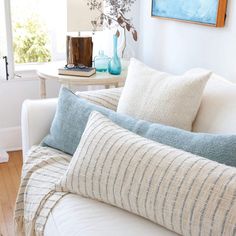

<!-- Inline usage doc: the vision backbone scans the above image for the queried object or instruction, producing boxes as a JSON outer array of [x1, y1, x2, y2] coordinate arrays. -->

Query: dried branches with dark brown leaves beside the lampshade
[[87, 0, 138, 41]]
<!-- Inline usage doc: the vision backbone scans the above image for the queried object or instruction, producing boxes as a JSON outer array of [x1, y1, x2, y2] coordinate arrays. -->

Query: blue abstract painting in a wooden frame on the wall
[[152, 0, 227, 27]]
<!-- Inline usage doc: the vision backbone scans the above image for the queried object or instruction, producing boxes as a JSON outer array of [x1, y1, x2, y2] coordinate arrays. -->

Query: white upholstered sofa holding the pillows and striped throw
[[22, 75, 236, 236]]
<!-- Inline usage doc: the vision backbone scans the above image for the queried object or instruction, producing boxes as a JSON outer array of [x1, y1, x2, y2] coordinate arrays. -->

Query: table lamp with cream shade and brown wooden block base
[[67, 0, 101, 67]]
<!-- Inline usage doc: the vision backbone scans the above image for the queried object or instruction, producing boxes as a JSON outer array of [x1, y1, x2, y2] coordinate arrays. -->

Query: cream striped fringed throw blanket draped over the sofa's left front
[[15, 146, 71, 236]]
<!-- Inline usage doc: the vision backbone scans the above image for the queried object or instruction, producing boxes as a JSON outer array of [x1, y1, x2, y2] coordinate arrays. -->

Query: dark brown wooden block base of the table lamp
[[67, 36, 93, 67]]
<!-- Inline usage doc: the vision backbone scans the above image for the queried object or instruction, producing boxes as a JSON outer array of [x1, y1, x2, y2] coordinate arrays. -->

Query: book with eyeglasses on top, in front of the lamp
[[58, 66, 96, 77]]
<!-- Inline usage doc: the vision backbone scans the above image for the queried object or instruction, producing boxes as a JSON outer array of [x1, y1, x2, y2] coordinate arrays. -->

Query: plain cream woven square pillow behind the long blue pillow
[[117, 59, 211, 131]]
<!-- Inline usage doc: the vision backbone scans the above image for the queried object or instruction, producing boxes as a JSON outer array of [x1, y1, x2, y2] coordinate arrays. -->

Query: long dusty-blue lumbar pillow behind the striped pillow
[[42, 88, 236, 167]]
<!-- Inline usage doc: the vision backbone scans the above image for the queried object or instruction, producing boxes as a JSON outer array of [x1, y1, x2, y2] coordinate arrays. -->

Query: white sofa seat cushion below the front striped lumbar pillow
[[44, 194, 177, 236]]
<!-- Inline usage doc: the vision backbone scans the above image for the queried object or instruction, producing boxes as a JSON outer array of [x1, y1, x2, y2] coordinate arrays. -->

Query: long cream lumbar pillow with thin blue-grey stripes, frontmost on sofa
[[59, 112, 236, 236]]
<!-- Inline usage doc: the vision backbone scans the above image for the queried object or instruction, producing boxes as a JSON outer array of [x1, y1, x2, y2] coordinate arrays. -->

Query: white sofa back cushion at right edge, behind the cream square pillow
[[191, 69, 236, 134]]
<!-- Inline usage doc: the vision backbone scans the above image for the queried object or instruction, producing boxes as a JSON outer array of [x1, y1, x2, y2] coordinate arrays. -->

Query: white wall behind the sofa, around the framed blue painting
[[136, 0, 236, 82]]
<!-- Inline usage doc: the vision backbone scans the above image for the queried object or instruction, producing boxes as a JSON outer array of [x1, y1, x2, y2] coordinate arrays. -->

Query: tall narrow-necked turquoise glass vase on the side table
[[108, 35, 122, 75]]
